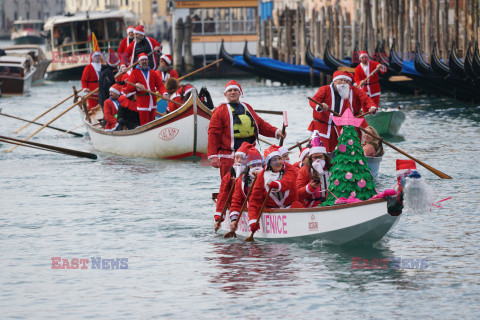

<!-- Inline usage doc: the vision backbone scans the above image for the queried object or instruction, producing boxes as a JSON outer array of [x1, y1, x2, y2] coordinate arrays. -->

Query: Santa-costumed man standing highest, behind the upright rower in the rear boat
[[122, 25, 162, 71]]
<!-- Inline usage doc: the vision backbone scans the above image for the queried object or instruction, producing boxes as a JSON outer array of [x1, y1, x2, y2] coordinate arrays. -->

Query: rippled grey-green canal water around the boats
[[0, 75, 480, 319]]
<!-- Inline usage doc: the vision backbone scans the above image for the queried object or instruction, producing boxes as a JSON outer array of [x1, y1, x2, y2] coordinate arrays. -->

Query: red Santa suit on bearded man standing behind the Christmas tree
[[308, 71, 376, 153]]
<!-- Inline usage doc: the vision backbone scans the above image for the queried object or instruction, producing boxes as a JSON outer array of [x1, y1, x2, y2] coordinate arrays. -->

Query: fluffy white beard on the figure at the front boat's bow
[[404, 177, 434, 213]]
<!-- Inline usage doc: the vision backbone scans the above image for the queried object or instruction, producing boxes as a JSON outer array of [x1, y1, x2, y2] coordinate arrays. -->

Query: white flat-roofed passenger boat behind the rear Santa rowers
[[44, 10, 134, 80]]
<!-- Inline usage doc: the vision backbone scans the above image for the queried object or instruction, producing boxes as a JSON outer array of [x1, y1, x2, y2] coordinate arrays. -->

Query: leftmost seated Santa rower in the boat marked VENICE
[[214, 142, 252, 231]]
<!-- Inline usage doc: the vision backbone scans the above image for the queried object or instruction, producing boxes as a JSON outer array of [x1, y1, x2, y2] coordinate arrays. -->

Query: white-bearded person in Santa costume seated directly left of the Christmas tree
[[297, 135, 332, 208]]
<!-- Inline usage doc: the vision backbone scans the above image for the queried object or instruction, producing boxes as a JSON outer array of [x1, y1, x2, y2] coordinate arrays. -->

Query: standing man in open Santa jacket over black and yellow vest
[[208, 80, 286, 177]]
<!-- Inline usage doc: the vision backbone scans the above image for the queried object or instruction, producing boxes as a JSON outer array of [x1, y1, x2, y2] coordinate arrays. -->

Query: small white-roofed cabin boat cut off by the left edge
[[0, 55, 36, 95]]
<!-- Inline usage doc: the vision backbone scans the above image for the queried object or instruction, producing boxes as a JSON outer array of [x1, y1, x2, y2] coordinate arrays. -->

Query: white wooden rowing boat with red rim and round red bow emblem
[[79, 91, 212, 159]]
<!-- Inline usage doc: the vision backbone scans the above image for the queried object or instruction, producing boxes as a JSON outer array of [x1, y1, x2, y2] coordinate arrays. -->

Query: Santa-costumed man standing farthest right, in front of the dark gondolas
[[355, 51, 387, 108]]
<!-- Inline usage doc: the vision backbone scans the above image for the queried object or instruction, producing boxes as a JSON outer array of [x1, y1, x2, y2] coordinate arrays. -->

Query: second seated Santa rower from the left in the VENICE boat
[[230, 142, 263, 231]]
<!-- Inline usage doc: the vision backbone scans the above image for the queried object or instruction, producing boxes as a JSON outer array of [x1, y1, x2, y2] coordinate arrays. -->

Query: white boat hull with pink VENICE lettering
[[221, 199, 401, 245]]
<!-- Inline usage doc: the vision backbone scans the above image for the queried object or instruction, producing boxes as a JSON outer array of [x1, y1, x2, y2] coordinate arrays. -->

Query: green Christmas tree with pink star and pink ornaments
[[322, 109, 377, 206]]
